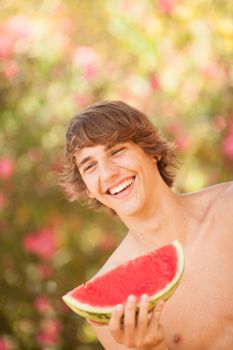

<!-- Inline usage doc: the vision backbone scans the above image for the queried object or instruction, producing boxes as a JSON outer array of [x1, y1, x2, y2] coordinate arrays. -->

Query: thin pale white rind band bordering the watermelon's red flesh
[[62, 240, 184, 317]]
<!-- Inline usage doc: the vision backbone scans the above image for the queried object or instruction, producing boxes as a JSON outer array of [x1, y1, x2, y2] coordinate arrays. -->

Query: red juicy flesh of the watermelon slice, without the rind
[[72, 245, 177, 306]]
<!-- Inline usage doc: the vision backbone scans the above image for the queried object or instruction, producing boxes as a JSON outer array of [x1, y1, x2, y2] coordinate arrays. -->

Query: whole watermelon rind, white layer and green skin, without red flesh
[[62, 240, 184, 323]]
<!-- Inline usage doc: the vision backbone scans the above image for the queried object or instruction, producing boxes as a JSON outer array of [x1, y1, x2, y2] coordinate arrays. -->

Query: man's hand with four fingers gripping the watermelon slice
[[109, 295, 168, 350]]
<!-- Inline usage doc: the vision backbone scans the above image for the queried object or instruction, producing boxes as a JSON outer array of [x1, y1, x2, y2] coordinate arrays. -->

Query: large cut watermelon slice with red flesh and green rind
[[63, 241, 184, 323]]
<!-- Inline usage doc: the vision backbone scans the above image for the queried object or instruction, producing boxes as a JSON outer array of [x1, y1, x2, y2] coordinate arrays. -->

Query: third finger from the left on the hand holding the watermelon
[[137, 294, 150, 346]]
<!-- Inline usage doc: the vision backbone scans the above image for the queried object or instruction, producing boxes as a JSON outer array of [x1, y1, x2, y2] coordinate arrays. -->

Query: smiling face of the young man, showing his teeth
[[75, 142, 158, 217]]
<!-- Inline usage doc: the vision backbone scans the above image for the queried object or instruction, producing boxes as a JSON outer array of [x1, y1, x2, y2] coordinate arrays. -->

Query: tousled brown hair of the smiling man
[[61, 101, 177, 208]]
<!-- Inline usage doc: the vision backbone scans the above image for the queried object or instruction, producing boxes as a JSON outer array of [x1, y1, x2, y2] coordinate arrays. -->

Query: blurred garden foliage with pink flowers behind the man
[[0, 0, 233, 350]]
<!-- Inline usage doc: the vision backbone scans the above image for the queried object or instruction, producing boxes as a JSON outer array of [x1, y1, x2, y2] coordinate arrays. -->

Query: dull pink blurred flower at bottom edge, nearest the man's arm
[[37, 319, 62, 346]]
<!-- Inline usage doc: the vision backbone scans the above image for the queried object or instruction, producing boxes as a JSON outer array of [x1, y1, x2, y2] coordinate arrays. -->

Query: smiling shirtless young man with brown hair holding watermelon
[[63, 101, 233, 350]]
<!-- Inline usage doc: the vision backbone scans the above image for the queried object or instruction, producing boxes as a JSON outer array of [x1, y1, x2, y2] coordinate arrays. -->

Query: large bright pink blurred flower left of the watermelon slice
[[23, 227, 56, 259]]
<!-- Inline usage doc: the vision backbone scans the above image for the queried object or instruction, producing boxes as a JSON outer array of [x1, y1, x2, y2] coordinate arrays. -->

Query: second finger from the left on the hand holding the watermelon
[[124, 295, 136, 347]]
